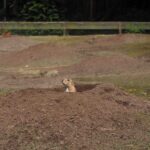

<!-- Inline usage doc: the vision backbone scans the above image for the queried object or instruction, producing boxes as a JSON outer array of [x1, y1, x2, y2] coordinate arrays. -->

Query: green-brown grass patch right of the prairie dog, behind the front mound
[[75, 73, 150, 100]]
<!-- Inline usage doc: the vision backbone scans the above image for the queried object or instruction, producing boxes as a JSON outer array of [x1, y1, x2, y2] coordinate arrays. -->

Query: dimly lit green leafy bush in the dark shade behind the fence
[[20, 0, 61, 21]]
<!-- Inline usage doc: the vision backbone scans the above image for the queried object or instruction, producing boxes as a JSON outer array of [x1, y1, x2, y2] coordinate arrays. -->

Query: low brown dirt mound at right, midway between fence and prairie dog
[[60, 54, 142, 75]]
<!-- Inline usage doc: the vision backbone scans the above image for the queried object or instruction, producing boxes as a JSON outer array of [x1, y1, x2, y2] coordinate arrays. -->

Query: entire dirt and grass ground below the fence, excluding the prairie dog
[[0, 34, 150, 150]]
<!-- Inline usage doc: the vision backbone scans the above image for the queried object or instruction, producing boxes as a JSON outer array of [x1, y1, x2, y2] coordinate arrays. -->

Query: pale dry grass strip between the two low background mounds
[[0, 55, 83, 74]]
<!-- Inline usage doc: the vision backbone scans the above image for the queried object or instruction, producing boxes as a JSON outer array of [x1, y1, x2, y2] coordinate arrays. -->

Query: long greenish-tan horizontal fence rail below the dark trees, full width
[[0, 22, 150, 34]]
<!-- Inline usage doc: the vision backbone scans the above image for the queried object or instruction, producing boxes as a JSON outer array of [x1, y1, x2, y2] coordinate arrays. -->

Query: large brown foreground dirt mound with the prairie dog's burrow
[[0, 84, 150, 150]]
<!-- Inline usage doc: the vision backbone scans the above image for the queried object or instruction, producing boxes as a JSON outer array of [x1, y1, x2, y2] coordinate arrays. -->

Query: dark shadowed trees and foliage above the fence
[[0, 0, 150, 21]]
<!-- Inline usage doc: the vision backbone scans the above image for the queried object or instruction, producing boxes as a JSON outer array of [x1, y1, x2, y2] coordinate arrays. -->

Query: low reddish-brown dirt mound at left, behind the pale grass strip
[[0, 44, 75, 66]]
